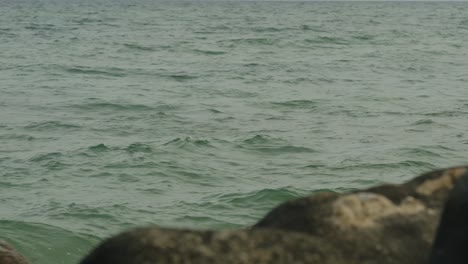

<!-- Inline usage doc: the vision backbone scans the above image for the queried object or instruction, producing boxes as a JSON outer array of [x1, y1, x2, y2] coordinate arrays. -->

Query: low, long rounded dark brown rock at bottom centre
[[81, 228, 346, 264]]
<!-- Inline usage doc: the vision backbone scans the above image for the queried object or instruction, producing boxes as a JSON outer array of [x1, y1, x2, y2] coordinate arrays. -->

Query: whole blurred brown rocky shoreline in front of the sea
[[0, 167, 468, 264]]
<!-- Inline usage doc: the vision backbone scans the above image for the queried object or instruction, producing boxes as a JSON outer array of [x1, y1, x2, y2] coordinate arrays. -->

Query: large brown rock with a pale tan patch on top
[[254, 167, 466, 264]]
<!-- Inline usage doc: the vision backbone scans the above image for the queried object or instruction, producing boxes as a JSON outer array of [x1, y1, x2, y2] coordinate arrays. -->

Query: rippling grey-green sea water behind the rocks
[[0, 0, 468, 264]]
